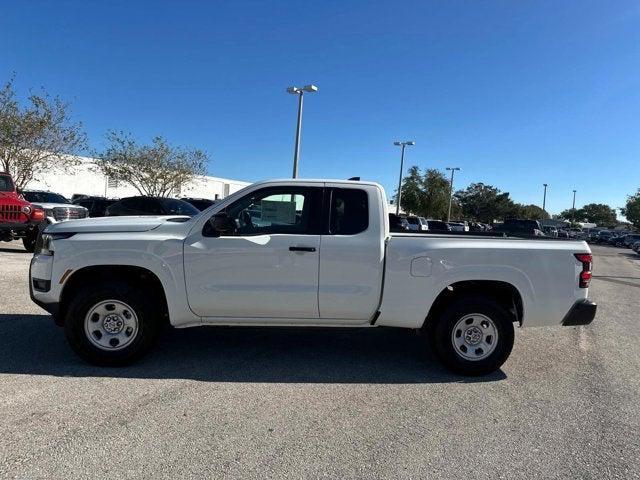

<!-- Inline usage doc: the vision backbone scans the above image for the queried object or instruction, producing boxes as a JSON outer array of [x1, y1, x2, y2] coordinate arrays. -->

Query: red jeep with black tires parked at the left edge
[[0, 172, 45, 252]]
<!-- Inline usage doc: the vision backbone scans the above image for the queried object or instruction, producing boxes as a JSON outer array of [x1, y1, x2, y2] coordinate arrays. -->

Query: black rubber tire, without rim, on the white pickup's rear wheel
[[427, 296, 514, 376]]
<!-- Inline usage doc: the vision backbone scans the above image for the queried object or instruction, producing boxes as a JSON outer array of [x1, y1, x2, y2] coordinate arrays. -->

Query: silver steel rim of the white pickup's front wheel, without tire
[[84, 300, 139, 351]]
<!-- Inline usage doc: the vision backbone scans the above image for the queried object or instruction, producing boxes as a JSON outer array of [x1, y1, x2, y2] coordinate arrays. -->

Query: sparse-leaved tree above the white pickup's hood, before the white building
[[97, 131, 208, 197]]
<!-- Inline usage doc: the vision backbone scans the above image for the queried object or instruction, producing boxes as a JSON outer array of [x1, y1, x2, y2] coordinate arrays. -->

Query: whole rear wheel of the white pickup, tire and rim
[[429, 297, 514, 376]]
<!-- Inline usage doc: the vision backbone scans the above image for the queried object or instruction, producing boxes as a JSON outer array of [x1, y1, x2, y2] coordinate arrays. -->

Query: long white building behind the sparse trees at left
[[26, 157, 250, 200]]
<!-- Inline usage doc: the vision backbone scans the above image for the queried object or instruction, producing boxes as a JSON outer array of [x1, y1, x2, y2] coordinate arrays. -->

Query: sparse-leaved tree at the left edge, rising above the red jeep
[[0, 78, 86, 188]]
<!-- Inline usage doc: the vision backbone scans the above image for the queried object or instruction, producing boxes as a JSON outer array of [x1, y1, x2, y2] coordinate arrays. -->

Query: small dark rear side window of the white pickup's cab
[[329, 188, 369, 235]]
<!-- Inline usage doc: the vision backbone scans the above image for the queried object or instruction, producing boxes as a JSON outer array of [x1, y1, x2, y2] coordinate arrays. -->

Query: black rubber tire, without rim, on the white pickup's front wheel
[[63, 281, 162, 367]]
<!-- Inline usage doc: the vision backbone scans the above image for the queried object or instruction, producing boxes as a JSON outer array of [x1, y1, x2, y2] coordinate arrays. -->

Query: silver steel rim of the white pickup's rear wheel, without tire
[[451, 313, 498, 361]]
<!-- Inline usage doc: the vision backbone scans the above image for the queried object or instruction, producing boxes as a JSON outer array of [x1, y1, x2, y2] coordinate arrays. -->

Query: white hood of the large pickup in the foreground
[[45, 215, 191, 233]]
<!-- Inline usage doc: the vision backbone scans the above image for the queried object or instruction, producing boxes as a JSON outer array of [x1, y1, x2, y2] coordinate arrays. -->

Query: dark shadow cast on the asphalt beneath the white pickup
[[0, 314, 506, 384]]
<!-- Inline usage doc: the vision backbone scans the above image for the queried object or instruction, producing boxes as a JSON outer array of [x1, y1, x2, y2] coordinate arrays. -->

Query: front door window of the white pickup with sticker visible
[[221, 187, 322, 235]]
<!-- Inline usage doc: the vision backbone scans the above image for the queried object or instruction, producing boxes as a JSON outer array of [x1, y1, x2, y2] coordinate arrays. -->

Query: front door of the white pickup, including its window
[[184, 186, 323, 319]]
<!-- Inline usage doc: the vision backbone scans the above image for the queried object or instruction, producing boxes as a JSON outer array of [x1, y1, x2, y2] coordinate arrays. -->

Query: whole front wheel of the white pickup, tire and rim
[[64, 281, 161, 366]]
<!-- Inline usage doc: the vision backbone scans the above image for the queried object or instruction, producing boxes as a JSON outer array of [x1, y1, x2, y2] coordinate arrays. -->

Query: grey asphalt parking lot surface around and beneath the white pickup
[[0, 243, 640, 479]]
